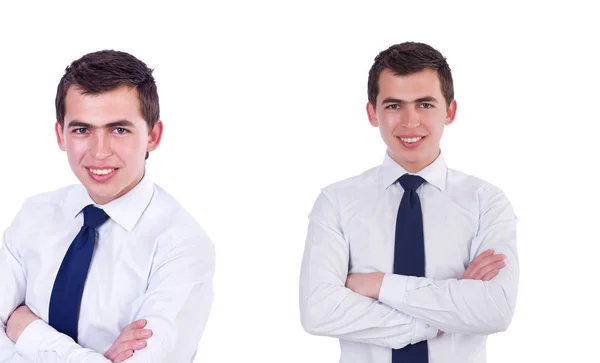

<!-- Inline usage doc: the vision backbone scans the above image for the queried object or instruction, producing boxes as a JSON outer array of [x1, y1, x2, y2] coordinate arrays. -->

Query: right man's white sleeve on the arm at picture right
[[379, 185, 519, 334]]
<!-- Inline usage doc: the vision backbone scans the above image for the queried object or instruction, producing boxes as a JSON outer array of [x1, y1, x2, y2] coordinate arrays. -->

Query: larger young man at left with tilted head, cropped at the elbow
[[0, 51, 215, 363]]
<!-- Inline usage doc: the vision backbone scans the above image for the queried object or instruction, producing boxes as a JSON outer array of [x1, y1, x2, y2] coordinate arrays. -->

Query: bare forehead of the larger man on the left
[[65, 86, 144, 125]]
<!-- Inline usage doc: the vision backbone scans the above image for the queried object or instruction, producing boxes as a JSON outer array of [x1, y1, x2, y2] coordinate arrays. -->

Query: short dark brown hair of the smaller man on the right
[[367, 42, 454, 107]]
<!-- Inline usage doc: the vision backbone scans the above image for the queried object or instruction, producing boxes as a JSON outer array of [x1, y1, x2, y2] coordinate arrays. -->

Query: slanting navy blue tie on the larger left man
[[48, 204, 108, 342]]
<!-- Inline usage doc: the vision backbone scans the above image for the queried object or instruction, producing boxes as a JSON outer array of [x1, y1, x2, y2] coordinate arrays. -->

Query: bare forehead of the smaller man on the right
[[377, 68, 442, 100]]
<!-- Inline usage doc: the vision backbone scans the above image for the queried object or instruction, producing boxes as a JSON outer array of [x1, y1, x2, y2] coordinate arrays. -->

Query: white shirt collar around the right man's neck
[[381, 151, 448, 191]]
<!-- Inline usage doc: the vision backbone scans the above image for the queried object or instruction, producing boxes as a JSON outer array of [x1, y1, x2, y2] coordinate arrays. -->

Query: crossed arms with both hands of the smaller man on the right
[[300, 189, 518, 348]]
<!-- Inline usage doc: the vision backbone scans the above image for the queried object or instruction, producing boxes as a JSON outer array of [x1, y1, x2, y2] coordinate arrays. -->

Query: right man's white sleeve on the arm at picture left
[[300, 191, 438, 349]]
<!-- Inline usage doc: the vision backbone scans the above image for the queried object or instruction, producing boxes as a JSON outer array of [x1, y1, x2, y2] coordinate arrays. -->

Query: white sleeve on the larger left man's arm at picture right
[[17, 236, 215, 363]]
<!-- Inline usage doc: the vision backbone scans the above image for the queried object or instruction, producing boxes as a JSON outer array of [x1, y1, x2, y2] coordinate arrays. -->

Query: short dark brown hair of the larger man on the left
[[55, 50, 160, 132]]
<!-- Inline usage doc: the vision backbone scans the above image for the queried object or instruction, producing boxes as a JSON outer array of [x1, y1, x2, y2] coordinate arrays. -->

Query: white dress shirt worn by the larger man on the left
[[0, 175, 215, 363]]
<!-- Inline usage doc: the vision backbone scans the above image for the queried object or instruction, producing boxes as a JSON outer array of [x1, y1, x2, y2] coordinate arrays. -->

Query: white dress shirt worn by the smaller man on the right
[[300, 154, 519, 363]]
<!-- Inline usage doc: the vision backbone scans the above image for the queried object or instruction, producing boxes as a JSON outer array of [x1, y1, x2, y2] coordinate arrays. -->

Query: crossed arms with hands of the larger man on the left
[[0, 231, 214, 363]]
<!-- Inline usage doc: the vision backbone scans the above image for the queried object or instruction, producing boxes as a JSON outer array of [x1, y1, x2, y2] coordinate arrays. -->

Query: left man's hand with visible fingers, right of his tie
[[104, 319, 152, 363]]
